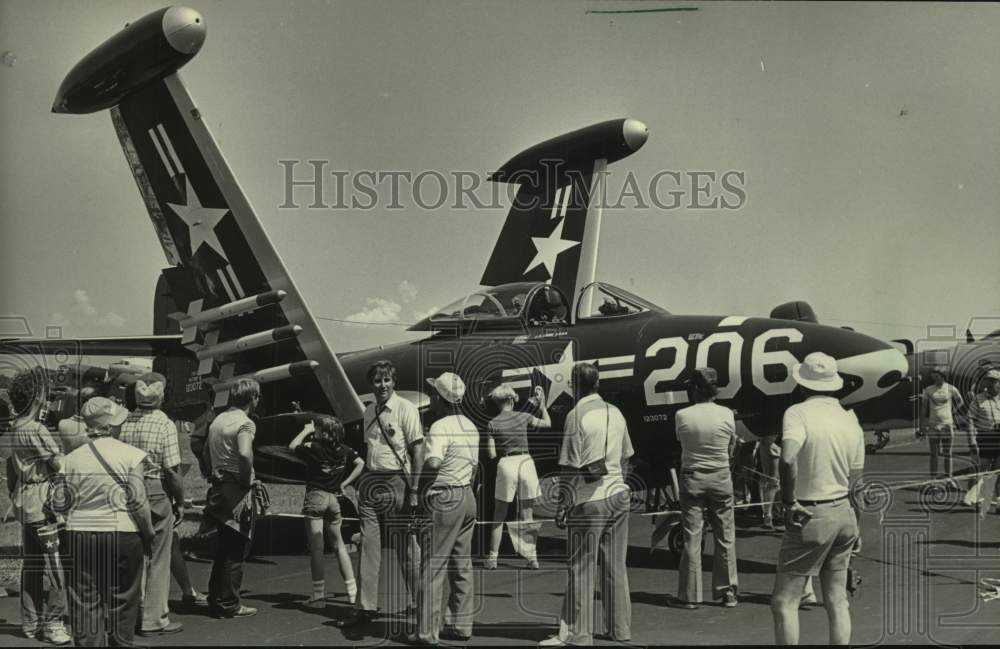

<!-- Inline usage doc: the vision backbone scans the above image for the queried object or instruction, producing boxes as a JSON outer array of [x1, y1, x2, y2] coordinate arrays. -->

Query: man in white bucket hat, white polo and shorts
[[771, 352, 865, 645]]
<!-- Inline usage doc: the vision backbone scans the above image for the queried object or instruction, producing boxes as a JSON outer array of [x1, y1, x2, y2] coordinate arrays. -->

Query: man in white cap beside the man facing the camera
[[410, 372, 479, 644]]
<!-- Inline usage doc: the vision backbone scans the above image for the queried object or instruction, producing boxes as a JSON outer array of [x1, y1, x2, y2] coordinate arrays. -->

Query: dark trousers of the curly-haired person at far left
[[21, 521, 66, 629]]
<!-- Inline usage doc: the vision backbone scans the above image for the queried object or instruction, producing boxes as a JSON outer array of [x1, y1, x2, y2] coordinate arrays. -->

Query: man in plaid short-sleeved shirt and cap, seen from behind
[[119, 372, 184, 636]]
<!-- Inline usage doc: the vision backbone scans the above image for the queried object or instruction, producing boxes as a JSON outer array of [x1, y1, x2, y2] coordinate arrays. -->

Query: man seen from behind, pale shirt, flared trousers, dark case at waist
[[538, 363, 634, 647]]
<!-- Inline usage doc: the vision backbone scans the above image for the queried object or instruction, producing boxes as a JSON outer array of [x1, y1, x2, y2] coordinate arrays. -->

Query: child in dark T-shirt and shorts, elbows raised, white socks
[[288, 415, 365, 608]]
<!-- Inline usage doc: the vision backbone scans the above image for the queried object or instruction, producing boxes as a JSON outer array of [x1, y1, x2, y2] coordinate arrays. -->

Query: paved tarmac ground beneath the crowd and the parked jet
[[0, 442, 1000, 646]]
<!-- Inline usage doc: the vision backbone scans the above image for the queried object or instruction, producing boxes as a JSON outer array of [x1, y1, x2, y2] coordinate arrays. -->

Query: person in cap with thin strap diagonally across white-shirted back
[[49, 397, 154, 647]]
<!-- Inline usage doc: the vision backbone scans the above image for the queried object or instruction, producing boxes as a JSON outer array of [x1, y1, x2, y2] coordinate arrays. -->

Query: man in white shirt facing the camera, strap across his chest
[[334, 361, 424, 628]]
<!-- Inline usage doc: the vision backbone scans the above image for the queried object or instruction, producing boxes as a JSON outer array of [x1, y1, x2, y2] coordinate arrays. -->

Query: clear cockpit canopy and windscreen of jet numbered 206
[[410, 282, 666, 331]]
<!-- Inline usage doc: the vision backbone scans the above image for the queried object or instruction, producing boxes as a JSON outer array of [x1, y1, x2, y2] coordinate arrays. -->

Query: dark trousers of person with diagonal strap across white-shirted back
[[61, 532, 144, 647]]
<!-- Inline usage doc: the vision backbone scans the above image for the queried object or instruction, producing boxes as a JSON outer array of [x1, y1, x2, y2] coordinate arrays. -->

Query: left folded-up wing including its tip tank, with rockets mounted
[[53, 7, 363, 421]]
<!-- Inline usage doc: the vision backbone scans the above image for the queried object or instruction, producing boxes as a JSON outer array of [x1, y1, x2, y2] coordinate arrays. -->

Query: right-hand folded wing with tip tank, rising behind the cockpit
[[480, 119, 648, 314]]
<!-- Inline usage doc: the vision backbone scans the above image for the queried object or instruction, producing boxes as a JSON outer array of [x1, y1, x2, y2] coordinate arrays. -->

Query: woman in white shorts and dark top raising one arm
[[486, 383, 552, 570]]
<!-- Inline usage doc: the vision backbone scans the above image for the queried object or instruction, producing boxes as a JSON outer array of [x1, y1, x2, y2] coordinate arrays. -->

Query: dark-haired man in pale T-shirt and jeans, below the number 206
[[675, 367, 739, 609]]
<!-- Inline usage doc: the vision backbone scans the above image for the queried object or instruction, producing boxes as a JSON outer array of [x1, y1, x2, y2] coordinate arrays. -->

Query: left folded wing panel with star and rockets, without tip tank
[[100, 73, 363, 420]]
